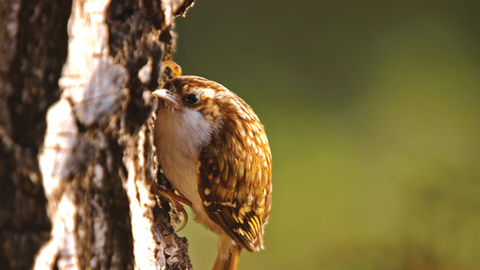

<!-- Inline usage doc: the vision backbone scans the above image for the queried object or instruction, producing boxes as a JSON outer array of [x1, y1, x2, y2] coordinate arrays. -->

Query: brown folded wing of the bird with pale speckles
[[197, 116, 271, 252]]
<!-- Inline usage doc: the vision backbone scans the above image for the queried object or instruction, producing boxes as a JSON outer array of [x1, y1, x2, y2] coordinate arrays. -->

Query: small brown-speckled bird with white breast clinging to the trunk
[[152, 71, 272, 270]]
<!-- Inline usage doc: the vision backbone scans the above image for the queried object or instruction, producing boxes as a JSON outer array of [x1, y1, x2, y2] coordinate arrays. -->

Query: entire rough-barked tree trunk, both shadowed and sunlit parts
[[0, 0, 193, 269]]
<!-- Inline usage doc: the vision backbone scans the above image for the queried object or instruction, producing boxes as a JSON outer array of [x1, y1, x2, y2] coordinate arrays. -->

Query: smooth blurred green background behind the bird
[[174, 0, 480, 270]]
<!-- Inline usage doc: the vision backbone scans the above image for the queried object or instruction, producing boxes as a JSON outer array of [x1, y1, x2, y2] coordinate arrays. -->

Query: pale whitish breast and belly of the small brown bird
[[155, 108, 223, 234]]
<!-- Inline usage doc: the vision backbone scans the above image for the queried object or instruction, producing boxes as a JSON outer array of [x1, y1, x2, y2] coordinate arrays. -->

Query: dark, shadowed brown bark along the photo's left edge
[[0, 0, 71, 269]]
